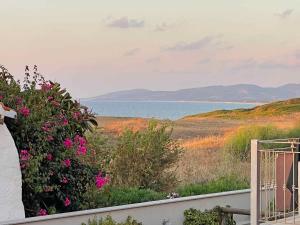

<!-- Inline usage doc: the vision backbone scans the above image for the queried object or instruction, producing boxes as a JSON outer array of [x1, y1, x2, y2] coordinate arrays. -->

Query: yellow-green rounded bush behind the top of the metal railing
[[225, 126, 285, 161]]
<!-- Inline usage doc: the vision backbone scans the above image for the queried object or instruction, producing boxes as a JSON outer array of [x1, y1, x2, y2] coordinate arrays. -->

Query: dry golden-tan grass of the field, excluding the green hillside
[[98, 113, 300, 184]]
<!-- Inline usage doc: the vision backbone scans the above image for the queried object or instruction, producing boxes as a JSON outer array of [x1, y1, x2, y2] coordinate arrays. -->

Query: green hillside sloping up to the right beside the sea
[[184, 98, 300, 119]]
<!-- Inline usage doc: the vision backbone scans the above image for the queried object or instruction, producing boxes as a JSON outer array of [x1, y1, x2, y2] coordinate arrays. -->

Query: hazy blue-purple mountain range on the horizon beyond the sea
[[82, 84, 300, 102]]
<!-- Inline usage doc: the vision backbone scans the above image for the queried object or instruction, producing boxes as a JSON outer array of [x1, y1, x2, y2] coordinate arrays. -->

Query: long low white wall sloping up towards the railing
[[4, 190, 250, 225]]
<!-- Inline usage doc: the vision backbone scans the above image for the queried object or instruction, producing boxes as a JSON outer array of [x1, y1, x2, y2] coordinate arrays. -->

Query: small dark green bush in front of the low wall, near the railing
[[183, 207, 236, 225]]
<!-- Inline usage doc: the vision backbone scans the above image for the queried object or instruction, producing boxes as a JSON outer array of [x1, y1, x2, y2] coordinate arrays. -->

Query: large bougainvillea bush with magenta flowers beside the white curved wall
[[0, 67, 108, 216]]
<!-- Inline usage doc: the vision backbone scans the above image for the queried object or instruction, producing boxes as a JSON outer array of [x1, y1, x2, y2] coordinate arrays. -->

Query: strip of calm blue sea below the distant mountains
[[81, 100, 258, 120]]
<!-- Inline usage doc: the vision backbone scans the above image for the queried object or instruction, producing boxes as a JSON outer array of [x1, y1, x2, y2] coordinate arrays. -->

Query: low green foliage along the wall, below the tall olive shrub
[[82, 186, 167, 209]]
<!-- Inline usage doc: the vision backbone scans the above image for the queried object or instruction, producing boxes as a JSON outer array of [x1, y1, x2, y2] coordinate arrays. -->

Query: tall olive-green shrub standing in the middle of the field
[[111, 121, 182, 190]]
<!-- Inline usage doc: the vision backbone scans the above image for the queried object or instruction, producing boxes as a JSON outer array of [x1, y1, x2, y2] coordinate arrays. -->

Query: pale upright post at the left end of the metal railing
[[251, 140, 260, 225]]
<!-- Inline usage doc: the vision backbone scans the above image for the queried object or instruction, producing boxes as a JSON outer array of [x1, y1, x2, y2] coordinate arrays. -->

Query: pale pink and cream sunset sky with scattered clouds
[[0, 0, 300, 98]]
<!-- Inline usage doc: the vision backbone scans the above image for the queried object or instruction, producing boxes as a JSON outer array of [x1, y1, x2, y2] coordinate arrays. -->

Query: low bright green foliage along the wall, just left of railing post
[[177, 176, 250, 197]]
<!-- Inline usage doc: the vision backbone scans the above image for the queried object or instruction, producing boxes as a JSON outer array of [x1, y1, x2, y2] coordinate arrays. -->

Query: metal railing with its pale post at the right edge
[[251, 138, 300, 225]]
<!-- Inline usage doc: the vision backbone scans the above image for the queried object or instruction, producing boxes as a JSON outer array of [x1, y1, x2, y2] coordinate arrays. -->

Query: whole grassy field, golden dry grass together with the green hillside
[[97, 99, 300, 184]]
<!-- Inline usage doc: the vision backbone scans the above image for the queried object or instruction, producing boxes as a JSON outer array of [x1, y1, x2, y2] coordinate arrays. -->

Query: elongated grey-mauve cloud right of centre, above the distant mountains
[[162, 36, 220, 52]]
